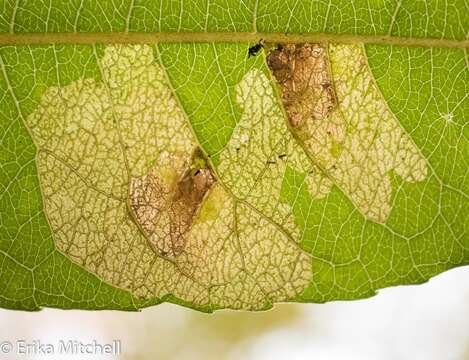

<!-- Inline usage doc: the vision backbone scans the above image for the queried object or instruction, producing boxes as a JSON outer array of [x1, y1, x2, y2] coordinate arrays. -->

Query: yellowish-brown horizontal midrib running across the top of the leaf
[[0, 32, 469, 49]]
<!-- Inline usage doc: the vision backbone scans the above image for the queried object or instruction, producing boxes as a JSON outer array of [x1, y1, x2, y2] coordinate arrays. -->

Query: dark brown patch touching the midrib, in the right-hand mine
[[267, 43, 337, 127]]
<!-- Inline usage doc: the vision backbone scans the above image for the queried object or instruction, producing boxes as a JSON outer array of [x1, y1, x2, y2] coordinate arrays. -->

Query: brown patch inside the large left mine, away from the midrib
[[129, 148, 216, 257]]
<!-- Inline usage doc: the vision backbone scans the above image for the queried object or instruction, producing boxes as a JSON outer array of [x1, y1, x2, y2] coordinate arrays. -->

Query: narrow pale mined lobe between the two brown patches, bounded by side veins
[[218, 70, 332, 231]]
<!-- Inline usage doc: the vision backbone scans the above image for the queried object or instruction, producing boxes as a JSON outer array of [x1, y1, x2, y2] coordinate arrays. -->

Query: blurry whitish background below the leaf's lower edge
[[0, 266, 469, 360]]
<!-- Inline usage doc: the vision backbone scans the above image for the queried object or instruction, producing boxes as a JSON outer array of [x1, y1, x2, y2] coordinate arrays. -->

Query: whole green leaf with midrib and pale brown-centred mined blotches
[[0, 0, 469, 312]]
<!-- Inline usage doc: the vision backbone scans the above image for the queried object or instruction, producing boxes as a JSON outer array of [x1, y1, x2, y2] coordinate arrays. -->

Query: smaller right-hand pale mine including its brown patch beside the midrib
[[269, 44, 427, 222]]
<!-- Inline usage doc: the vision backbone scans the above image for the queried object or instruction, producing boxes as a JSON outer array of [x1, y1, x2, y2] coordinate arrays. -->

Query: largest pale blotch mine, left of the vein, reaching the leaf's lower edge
[[27, 45, 312, 309]]
